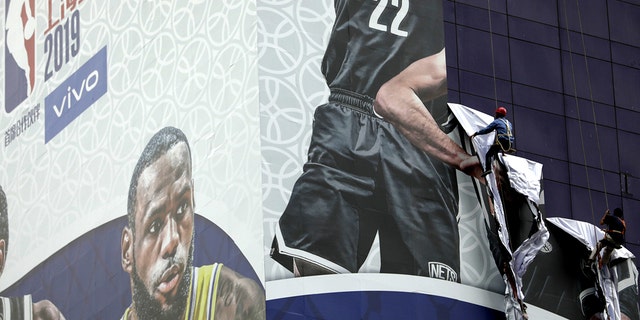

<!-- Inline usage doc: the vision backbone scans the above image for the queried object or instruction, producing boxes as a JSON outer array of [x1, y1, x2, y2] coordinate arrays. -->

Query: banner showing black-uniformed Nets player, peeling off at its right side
[[258, 0, 639, 319]]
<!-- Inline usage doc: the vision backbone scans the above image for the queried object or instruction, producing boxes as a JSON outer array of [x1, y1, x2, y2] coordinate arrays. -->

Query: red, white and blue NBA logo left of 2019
[[4, 0, 36, 113]]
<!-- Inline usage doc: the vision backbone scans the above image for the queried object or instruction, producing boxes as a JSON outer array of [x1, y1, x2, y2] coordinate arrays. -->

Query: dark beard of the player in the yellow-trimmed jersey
[[131, 237, 195, 320]]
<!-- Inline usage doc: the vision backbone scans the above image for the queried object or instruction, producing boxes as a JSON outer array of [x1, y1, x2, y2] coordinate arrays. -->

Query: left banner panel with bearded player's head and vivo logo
[[0, 0, 265, 319]]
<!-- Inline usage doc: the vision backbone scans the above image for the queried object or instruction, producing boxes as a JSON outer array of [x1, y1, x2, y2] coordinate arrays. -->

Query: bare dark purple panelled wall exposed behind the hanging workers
[[444, 0, 640, 256]]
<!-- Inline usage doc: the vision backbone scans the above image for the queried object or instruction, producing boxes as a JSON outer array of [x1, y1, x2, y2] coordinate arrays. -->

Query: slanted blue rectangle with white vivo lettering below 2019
[[44, 47, 108, 143]]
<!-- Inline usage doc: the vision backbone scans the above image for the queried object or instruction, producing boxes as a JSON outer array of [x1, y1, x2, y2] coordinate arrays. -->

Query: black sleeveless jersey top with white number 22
[[322, 0, 444, 98]]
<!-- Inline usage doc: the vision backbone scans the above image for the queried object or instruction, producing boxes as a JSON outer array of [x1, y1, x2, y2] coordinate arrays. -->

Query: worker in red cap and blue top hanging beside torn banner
[[471, 107, 514, 176]]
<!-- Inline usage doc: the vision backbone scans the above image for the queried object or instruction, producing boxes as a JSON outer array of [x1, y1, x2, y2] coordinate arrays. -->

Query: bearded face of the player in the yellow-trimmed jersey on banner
[[131, 142, 194, 319]]
